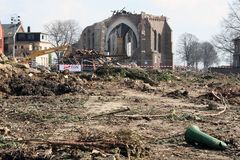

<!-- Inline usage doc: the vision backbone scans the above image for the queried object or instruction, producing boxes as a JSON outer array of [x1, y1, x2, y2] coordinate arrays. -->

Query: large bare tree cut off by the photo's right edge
[[213, 0, 240, 62]]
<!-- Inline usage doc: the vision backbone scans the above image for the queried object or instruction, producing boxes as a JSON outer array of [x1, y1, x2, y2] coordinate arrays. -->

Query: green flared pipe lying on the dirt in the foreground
[[185, 125, 227, 150]]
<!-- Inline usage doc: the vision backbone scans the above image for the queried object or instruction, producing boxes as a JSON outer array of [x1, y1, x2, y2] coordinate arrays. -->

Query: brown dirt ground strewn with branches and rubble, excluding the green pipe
[[0, 66, 240, 160]]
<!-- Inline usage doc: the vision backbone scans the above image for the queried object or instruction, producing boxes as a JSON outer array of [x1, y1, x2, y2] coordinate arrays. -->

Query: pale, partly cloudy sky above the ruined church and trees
[[0, 0, 233, 64]]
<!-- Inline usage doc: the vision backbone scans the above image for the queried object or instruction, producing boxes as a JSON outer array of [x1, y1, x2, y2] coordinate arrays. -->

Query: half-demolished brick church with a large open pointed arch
[[78, 10, 173, 68]]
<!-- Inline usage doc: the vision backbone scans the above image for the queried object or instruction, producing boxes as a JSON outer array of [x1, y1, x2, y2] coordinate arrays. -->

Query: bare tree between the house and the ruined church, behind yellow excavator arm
[[44, 20, 80, 62]]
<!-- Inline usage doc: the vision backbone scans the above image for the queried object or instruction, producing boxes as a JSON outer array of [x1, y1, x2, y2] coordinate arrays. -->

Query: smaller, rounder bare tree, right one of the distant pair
[[200, 42, 219, 69]]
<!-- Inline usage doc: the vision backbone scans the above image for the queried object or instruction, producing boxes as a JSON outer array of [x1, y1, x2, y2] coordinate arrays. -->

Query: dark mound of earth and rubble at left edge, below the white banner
[[0, 65, 83, 96]]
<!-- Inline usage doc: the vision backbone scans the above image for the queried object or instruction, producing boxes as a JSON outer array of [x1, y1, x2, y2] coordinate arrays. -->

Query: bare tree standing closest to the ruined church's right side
[[177, 33, 200, 67]]
